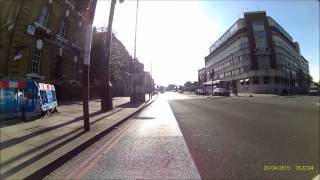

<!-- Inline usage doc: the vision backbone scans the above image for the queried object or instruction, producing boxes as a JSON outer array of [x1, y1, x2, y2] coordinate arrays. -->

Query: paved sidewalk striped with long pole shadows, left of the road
[[0, 97, 156, 179]]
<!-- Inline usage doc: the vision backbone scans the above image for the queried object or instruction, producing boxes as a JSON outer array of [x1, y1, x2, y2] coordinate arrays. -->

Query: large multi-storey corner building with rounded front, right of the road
[[205, 11, 309, 94]]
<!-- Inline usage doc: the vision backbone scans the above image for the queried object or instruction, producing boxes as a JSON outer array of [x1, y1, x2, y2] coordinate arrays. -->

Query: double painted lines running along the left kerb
[[65, 120, 136, 180]]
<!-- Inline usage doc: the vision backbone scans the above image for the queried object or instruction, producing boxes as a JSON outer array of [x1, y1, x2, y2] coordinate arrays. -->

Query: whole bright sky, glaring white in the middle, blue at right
[[93, 0, 319, 86]]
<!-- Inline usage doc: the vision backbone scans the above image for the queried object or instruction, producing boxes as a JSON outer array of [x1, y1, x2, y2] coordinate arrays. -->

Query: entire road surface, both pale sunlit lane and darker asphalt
[[45, 93, 319, 179]]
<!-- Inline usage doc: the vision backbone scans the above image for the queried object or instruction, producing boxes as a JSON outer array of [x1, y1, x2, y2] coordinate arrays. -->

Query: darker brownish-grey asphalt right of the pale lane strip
[[169, 92, 319, 179]]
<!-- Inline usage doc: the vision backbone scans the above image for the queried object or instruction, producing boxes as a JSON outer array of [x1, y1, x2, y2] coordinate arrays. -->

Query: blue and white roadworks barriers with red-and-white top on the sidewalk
[[0, 80, 58, 119]]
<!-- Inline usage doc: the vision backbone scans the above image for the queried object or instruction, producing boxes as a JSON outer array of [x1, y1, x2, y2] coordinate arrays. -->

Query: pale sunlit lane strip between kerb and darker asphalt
[[45, 95, 200, 179]]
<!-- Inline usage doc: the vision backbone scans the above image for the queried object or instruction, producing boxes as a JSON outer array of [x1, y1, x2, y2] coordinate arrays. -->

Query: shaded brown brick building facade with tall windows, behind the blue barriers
[[0, 0, 89, 100]]
